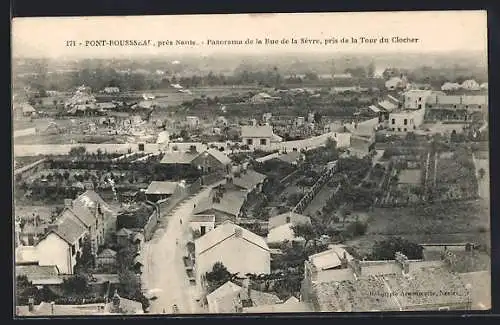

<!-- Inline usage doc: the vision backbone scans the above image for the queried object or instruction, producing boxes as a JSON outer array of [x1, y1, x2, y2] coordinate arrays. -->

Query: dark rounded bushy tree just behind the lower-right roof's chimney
[[371, 237, 423, 260]]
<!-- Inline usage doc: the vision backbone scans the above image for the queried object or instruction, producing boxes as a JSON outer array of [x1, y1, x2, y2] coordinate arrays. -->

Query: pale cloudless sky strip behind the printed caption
[[12, 11, 487, 58]]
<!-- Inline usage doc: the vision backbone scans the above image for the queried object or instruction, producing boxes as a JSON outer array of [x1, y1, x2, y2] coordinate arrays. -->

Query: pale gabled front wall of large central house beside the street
[[196, 236, 271, 283]]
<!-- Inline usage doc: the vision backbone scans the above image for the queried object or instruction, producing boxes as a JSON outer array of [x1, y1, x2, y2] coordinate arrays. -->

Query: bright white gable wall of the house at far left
[[36, 234, 72, 274]]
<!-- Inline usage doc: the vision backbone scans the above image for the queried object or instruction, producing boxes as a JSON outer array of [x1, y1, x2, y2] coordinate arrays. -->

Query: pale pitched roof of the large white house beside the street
[[195, 221, 269, 256]]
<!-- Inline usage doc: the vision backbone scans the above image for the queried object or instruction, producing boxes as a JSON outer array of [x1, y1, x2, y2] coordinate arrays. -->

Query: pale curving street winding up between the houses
[[142, 182, 221, 314]]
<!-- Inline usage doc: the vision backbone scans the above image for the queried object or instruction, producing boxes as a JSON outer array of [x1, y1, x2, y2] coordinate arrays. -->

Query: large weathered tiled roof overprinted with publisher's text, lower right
[[313, 261, 468, 312]]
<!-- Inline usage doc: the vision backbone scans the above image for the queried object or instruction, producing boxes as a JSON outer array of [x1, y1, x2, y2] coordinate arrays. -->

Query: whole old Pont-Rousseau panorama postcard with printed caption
[[11, 10, 491, 318]]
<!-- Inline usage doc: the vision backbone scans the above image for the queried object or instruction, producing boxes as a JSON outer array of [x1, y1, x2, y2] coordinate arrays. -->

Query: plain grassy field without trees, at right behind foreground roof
[[347, 200, 490, 254]]
